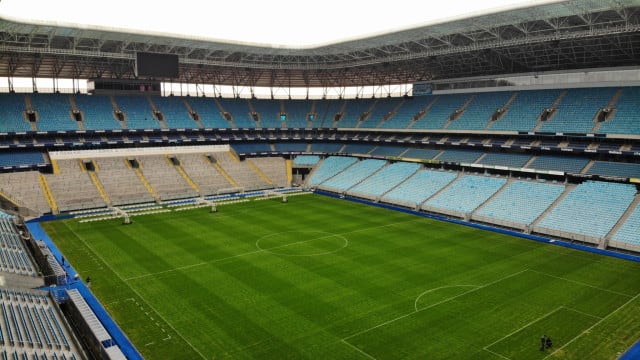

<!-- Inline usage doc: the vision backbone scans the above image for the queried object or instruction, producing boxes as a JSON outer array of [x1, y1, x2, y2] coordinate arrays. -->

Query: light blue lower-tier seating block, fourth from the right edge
[[422, 175, 507, 215]]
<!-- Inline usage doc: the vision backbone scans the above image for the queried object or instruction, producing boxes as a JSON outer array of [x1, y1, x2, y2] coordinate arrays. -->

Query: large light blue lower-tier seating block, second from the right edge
[[538, 181, 636, 238]]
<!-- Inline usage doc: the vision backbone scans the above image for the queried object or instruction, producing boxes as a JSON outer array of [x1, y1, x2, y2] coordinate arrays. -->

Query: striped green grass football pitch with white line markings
[[42, 195, 640, 360]]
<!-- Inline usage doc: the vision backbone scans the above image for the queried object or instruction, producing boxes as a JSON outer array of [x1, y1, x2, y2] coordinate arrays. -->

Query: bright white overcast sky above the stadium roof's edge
[[0, 0, 559, 48]]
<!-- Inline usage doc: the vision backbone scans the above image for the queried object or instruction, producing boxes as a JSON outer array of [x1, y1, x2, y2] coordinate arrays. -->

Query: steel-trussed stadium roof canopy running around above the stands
[[0, 0, 640, 87]]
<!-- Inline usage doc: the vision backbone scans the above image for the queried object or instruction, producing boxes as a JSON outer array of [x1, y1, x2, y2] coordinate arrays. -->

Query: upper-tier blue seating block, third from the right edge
[[489, 89, 560, 131]]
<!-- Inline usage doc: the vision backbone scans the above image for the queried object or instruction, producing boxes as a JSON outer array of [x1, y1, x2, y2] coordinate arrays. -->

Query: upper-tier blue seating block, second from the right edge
[[540, 88, 617, 133]]
